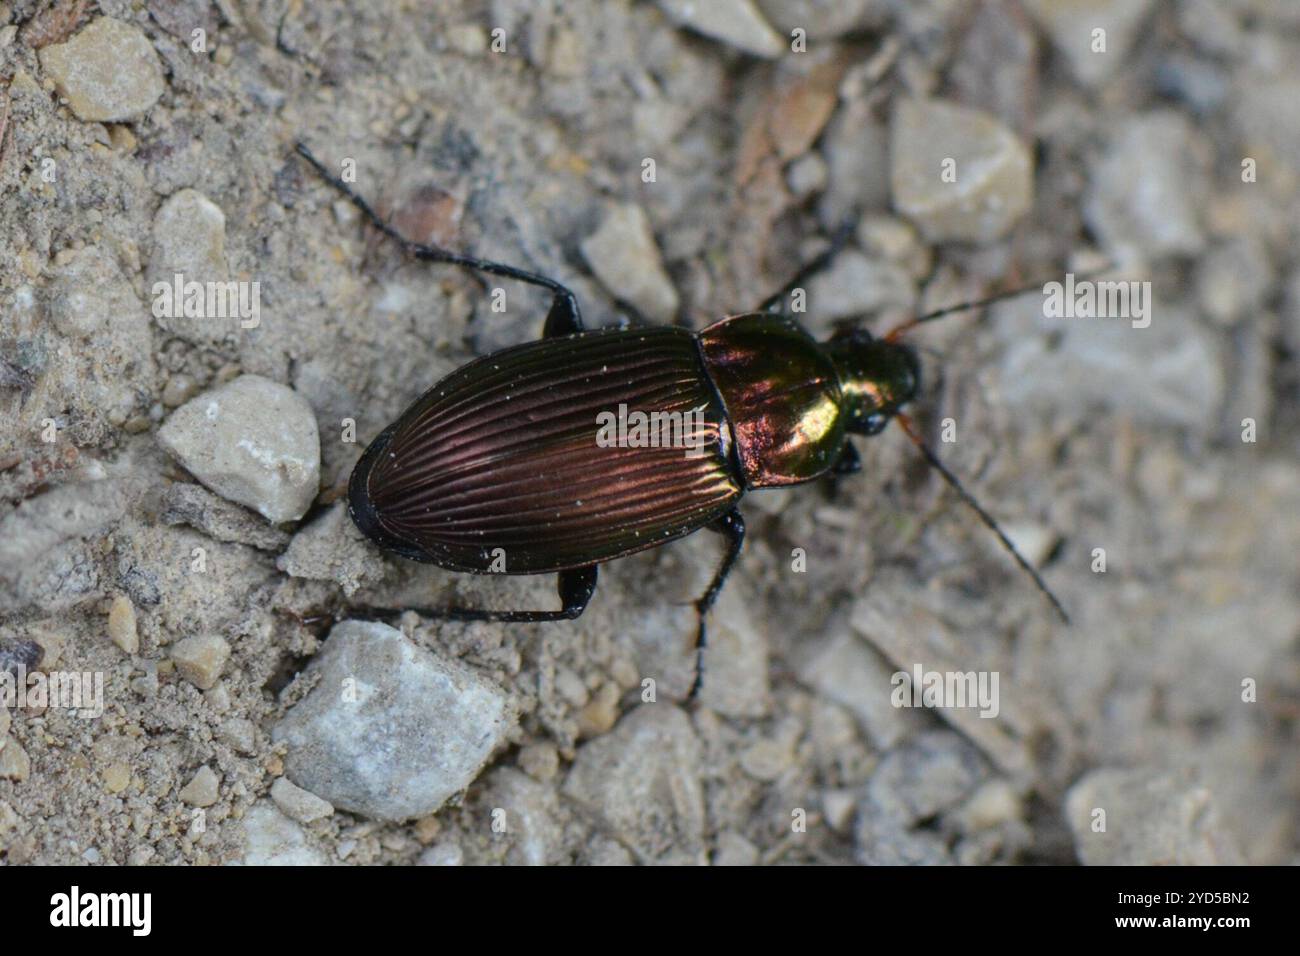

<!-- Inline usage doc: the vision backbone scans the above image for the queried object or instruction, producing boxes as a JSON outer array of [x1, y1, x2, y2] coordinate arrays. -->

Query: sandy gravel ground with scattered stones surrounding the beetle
[[0, 0, 1300, 864]]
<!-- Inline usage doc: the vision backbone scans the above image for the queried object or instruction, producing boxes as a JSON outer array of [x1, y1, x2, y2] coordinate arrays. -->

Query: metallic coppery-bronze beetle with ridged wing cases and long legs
[[296, 143, 1067, 695]]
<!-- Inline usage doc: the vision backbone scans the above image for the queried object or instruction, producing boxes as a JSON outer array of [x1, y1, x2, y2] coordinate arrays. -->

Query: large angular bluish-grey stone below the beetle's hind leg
[[272, 620, 515, 819]]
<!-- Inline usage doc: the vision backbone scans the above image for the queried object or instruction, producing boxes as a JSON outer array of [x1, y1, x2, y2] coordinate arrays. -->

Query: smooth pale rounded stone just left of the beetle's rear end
[[159, 375, 321, 524]]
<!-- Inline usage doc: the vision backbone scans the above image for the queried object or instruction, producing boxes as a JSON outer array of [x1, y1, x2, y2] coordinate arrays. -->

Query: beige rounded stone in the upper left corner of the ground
[[40, 17, 166, 122]]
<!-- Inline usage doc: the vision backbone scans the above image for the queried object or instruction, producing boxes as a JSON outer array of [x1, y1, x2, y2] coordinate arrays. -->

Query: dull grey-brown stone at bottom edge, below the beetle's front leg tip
[[564, 704, 706, 864]]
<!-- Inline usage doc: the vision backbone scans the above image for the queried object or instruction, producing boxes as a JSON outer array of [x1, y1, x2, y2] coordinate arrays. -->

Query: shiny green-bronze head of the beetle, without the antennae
[[826, 328, 920, 434]]
